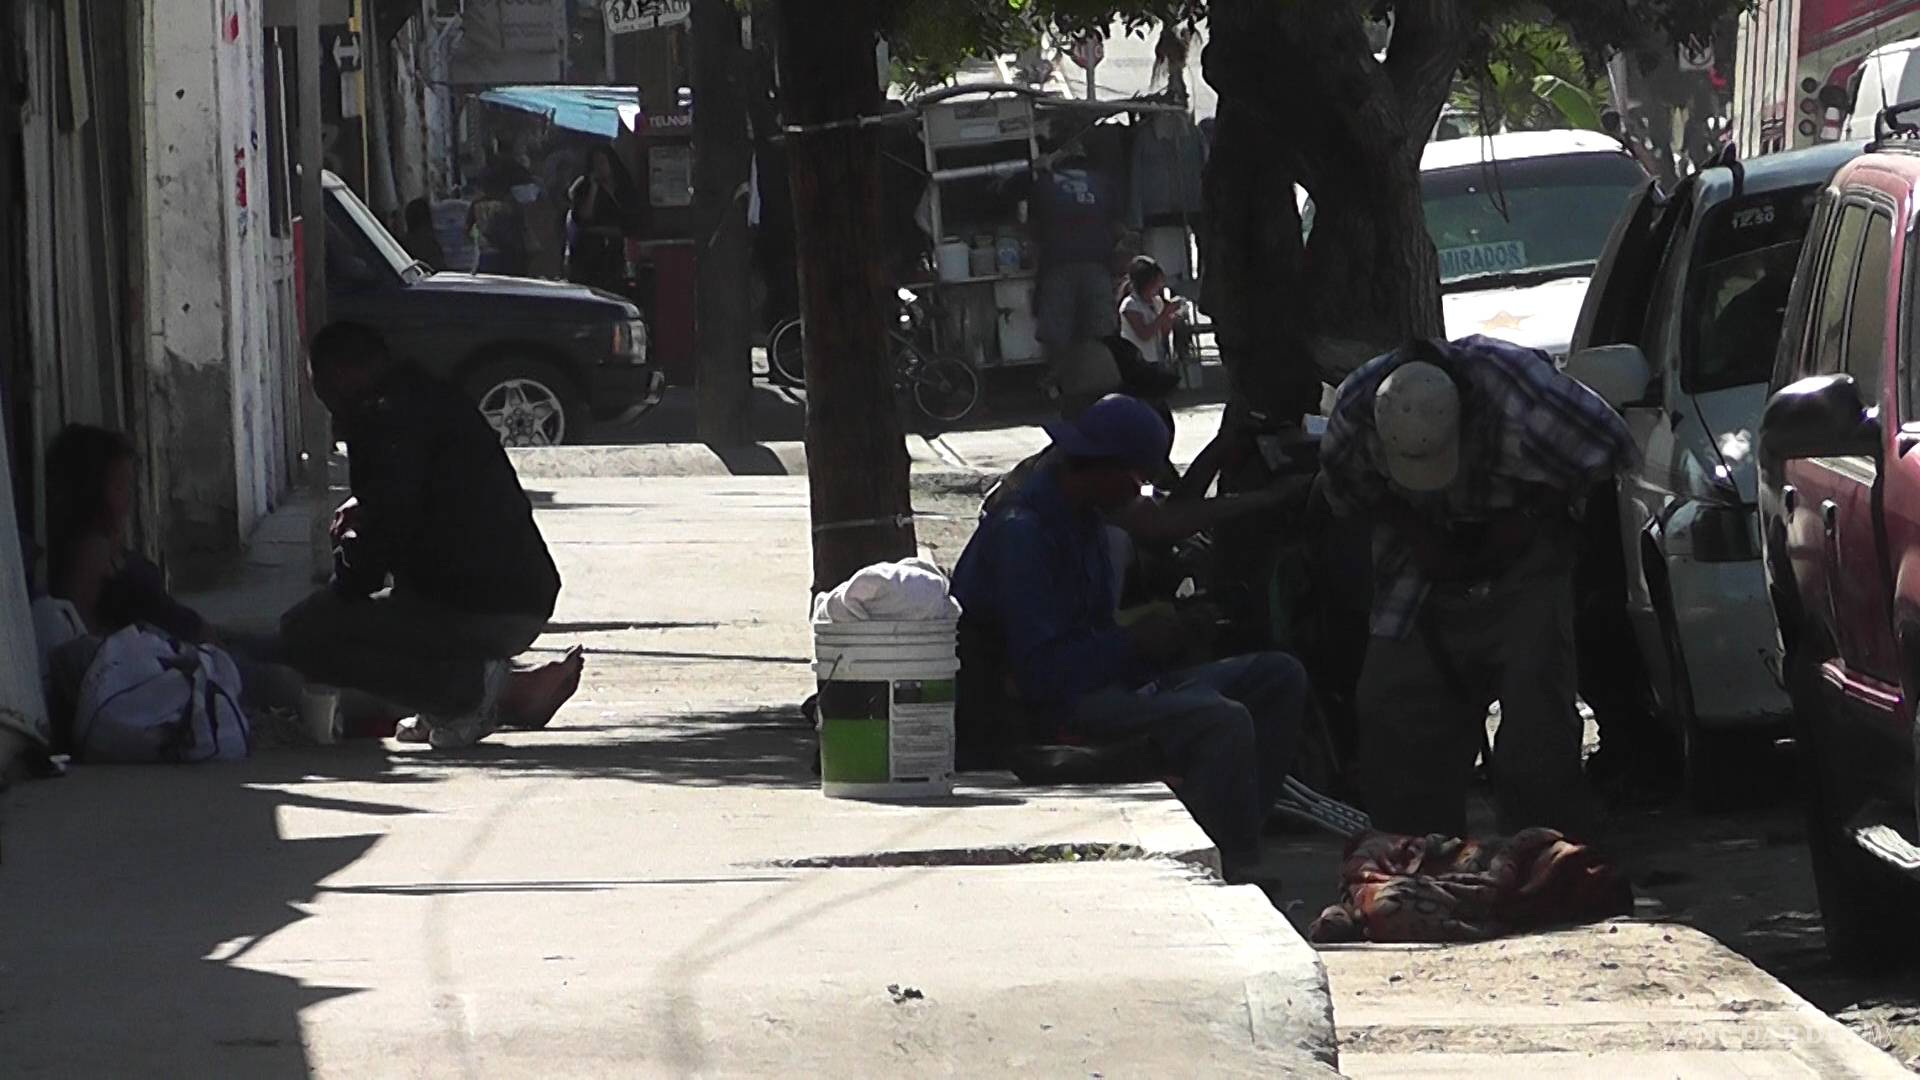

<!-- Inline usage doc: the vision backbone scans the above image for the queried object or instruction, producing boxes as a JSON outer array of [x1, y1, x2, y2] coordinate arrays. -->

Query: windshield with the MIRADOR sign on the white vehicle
[[1421, 154, 1647, 288]]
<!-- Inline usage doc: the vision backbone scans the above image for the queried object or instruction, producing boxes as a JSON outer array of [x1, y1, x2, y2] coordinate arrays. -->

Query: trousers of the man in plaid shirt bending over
[[1359, 552, 1594, 836]]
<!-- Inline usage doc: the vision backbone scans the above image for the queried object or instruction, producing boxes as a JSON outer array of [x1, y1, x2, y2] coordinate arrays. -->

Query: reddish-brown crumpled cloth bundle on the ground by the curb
[[1308, 828, 1634, 944]]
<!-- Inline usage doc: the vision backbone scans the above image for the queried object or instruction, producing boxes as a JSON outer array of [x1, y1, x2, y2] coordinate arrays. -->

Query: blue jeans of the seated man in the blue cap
[[1071, 653, 1308, 855]]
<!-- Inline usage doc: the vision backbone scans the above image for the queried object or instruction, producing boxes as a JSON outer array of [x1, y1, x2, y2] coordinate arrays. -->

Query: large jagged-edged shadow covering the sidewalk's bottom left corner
[[0, 759, 405, 1076]]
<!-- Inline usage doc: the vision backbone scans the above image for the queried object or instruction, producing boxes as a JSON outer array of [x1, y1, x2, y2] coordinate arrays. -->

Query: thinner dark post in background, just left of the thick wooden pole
[[691, 0, 753, 446]]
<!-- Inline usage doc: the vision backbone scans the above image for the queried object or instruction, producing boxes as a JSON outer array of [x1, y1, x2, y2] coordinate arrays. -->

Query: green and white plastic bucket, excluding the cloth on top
[[814, 619, 960, 799]]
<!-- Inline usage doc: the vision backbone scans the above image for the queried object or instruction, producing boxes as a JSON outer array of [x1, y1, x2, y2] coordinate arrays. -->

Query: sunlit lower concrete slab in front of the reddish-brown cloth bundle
[[1325, 920, 1910, 1080]]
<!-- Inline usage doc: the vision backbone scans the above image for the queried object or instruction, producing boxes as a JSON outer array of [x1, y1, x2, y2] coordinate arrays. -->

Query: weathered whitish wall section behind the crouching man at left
[[140, 0, 298, 580]]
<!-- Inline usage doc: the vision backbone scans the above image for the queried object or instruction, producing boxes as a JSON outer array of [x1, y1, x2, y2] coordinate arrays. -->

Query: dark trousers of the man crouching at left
[[280, 590, 547, 717]]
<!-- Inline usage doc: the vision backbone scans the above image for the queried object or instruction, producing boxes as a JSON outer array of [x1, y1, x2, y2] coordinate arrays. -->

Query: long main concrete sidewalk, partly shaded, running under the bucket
[[0, 466, 1334, 1076]]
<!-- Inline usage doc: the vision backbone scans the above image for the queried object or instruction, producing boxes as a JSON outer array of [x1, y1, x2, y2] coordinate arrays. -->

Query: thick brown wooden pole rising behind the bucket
[[780, 0, 914, 592]]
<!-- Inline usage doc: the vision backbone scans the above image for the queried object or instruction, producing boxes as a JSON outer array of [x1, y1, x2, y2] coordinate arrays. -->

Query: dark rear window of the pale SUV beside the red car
[[1680, 184, 1820, 394]]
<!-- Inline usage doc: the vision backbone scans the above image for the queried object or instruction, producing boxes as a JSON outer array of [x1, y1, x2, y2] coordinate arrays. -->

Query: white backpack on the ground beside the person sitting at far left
[[73, 626, 252, 765]]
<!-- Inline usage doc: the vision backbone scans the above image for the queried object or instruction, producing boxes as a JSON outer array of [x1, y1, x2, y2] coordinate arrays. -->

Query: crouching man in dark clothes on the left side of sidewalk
[[280, 323, 582, 749]]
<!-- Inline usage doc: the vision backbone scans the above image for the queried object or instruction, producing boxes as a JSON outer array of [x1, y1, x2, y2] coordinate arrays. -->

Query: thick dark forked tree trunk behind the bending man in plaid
[[1204, 0, 1465, 407]]
